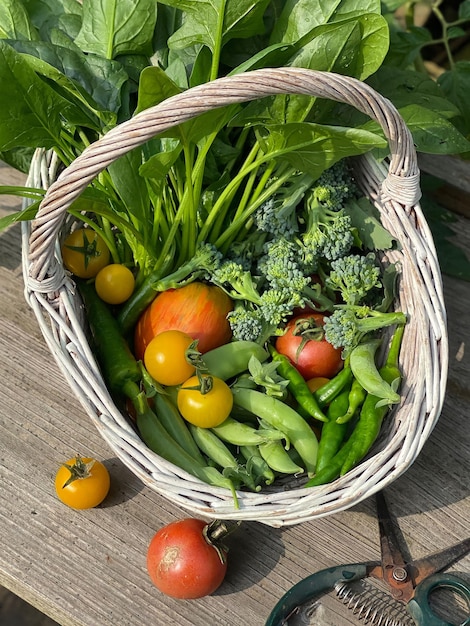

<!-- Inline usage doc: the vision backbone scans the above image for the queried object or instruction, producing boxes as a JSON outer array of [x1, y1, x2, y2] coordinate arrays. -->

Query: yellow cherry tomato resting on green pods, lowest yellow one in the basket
[[176, 376, 233, 428]]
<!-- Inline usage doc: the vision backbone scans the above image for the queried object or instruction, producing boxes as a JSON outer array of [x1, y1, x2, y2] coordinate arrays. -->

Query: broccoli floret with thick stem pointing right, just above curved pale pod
[[323, 305, 406, 358]]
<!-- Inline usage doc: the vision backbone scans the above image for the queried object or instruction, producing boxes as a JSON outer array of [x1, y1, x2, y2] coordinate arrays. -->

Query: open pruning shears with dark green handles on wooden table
[[265, 492, 470, 626]]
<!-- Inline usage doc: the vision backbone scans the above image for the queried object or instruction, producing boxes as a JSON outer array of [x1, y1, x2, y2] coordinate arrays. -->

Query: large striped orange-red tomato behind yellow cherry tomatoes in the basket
[[134, 282, 233, 359]]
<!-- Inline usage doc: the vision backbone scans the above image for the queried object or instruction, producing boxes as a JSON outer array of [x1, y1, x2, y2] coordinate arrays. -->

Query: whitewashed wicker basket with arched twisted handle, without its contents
[[23, 68, 448, 526]]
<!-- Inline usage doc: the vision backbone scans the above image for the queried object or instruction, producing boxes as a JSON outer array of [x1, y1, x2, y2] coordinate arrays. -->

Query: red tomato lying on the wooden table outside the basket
[[147, 518, 227, 600]]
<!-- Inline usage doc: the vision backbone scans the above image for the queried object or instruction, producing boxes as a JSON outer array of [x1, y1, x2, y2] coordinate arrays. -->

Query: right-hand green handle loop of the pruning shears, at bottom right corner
[[406, 574, 470, 626]]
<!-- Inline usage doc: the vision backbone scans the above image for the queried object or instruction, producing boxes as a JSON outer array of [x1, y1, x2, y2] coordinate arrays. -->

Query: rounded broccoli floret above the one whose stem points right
[[326, 253, 382, 305]]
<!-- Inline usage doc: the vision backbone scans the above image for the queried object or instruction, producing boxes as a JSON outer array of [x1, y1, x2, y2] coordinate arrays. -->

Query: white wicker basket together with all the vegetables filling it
[[0, 3, 447, 525]]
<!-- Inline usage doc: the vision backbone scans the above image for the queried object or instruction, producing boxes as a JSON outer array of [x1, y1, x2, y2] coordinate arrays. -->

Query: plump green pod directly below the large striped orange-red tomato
[[202, 341, 269, 380]]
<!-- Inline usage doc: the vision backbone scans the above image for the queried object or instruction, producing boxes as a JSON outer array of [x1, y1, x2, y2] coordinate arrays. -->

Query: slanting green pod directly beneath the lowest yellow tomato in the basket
[[189, 424, 261, 491]]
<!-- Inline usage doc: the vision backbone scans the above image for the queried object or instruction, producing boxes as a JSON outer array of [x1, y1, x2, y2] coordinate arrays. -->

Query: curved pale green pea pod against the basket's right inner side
[[350, 339, 400, 404]]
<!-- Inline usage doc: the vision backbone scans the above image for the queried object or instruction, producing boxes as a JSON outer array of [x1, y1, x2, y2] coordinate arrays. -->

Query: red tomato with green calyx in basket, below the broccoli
[[276, 312, 343, 380]]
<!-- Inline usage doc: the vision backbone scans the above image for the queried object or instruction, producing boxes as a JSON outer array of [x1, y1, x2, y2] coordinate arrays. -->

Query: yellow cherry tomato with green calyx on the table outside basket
[[54, 456, 111, 509]]
